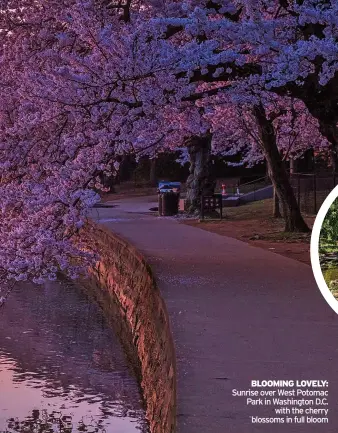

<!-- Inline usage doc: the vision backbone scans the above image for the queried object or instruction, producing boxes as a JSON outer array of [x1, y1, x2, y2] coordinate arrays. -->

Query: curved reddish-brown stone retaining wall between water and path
[[81, 223, 176, 433]]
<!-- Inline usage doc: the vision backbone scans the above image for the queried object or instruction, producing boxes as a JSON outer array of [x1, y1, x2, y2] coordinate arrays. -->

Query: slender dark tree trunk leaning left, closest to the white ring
[[253, 104, 309, 232]]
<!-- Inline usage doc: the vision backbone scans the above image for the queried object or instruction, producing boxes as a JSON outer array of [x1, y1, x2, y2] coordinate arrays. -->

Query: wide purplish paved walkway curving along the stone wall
[[94, 198, 338, 433]]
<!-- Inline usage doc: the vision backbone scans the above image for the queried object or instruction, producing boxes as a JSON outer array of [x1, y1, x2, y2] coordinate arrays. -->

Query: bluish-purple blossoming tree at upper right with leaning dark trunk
[[144, 0, 338, 226]]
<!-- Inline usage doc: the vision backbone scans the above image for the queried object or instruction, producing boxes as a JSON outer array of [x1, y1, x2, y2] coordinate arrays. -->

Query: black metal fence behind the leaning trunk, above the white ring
[[290, 172, 338, 215]]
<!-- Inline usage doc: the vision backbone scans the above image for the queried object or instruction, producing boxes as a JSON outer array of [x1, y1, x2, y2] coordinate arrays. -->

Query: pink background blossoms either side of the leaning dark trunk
[[207, 94, 329, 167]]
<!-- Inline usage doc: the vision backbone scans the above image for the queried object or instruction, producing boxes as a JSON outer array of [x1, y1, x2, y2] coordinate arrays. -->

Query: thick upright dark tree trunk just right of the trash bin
[[186, 134, 215, 213]]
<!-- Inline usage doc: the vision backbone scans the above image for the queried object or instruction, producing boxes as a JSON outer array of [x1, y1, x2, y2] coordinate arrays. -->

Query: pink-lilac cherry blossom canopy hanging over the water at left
[[0, 0, 200, 290]]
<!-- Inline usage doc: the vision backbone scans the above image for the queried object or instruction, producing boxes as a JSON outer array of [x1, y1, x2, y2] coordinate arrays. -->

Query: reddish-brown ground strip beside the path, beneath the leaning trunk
[[181, 199, 315, 264]]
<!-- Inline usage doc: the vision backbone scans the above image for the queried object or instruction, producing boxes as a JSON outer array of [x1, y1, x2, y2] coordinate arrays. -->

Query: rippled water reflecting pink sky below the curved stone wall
[[0, 282, 148, 433]]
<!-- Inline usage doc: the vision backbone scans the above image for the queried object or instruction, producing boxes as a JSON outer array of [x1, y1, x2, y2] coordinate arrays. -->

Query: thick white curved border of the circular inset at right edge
[[310, 186, 338, 314]]
